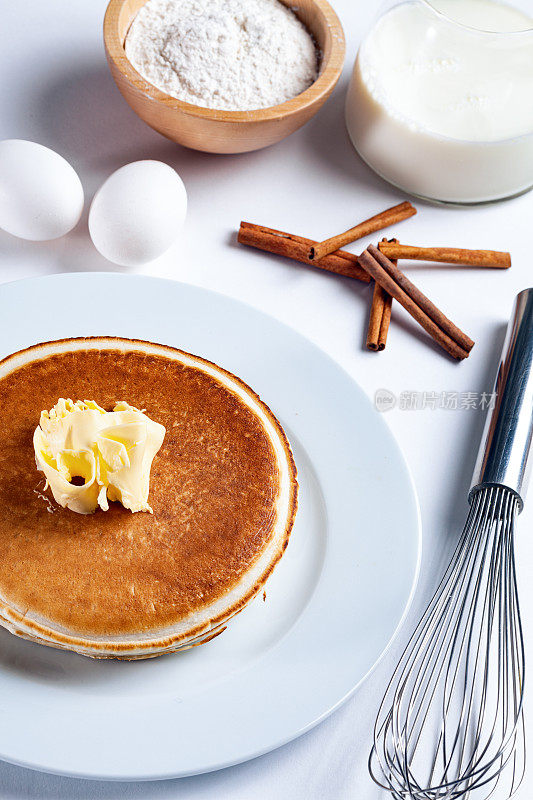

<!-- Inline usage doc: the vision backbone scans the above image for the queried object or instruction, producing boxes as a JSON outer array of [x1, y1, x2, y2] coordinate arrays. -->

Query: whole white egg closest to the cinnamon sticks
[[89, 161, 187, 267]]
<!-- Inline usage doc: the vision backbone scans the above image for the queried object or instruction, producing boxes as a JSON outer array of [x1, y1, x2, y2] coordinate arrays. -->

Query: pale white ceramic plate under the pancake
[[0, 273, 420, 780]]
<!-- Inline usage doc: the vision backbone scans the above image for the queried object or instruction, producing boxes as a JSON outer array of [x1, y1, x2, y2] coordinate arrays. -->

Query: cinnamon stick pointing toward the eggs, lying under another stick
[[237, 222, 370, 283]]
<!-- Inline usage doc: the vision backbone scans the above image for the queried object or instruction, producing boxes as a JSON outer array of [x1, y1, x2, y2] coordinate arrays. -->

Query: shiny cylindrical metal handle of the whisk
[[470, 289, 533, 510]]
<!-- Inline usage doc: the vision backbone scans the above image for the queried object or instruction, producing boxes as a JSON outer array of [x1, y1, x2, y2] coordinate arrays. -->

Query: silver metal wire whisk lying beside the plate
[[369, 289, 533, 800]]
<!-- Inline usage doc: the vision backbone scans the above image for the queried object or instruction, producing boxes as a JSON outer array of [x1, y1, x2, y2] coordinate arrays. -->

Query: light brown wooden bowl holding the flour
[[104, 0, 345, 153]]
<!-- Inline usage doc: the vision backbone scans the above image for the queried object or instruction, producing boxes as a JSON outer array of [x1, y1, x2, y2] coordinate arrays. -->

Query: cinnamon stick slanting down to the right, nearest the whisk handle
[[359, 245, 474, 360]]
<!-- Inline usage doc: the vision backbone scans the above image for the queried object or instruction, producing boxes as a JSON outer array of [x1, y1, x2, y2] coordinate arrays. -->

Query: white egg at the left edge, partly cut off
[[0, 139, 83, 241]]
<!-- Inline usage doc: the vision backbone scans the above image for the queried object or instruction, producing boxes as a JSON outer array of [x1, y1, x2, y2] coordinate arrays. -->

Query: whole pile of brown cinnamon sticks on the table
[[238, 202, 511, 360]]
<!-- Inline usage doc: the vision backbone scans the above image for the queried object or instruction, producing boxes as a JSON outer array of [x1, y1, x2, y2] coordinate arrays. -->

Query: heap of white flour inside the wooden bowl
[[125, 0, 318, 111]]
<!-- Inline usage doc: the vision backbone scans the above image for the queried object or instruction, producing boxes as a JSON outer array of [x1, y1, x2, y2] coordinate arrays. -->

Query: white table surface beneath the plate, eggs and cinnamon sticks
[[0, 0, 533, 800]]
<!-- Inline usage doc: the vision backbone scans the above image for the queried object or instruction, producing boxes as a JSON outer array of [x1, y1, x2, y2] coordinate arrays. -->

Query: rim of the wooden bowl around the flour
[[104, 0, 346, 123]]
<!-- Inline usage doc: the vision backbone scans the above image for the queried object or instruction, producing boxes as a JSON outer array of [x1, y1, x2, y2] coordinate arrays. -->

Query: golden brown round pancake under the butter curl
[[0, 338, 297, 658]]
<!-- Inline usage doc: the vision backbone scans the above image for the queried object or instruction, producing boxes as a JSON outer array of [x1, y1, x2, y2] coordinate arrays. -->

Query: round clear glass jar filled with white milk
[[346, 0, 533, 203]]
